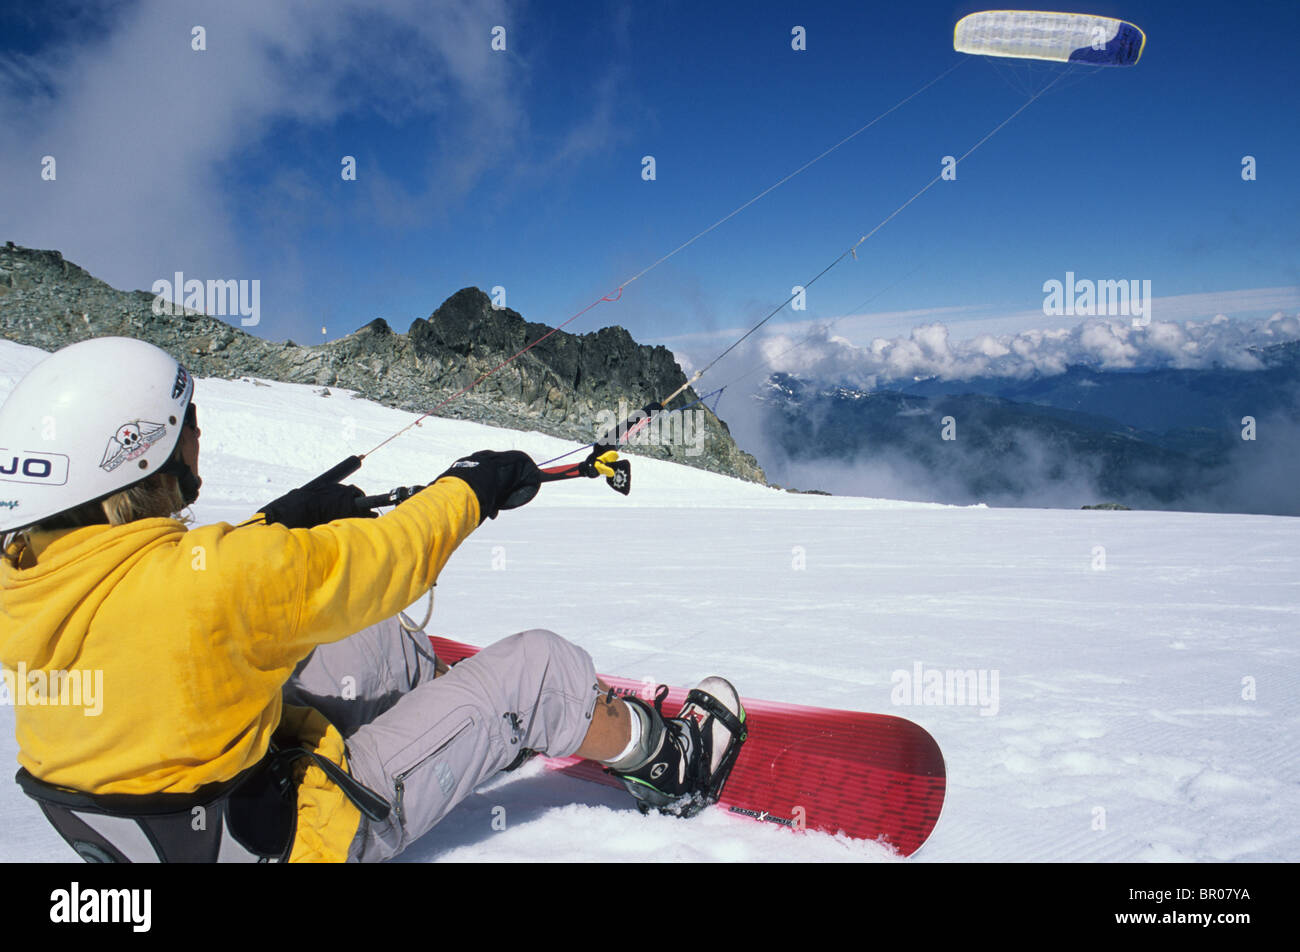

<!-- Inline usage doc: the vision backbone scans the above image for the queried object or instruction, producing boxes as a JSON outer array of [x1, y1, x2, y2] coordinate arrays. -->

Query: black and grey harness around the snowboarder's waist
[[14, 745, 389, 862]]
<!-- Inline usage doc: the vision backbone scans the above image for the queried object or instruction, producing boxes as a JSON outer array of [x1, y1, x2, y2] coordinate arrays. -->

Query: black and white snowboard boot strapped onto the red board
[[610, 678, 746, 817]]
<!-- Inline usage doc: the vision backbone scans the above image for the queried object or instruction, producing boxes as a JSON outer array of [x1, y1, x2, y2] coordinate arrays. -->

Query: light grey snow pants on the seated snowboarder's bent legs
[[285, 618, 599, 862]]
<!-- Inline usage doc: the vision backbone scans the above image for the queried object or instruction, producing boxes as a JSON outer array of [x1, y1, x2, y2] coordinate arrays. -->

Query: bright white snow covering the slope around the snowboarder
[[0, 342, 1300, 862]]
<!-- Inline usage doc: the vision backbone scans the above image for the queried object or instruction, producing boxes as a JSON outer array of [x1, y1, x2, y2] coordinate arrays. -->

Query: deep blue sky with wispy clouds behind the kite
[[0, 0, 1300, 371]]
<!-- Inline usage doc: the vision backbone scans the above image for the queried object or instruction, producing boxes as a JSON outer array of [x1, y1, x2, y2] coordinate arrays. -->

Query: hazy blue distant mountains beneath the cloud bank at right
[[761, 342, 1300, 515]]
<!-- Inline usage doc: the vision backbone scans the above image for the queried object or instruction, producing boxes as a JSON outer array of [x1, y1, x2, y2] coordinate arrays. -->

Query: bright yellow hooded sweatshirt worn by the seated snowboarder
[[0, 479, 478, 862]]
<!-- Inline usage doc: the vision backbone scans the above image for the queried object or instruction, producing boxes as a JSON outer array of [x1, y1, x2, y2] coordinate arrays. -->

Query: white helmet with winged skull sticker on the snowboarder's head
[[0, 337, 198, 532]]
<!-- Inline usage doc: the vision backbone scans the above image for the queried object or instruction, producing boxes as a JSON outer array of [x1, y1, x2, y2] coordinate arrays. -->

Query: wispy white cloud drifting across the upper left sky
[[0, 0, 527, 286]]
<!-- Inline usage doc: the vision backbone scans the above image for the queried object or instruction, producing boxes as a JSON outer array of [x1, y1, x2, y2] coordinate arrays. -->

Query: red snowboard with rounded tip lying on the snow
[[429, 637, 946, 856]]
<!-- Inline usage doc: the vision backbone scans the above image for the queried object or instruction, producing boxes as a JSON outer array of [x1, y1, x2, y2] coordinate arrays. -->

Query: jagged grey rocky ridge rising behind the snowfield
[[0, 242, 767, 484]]
